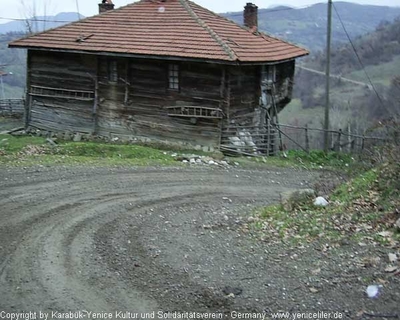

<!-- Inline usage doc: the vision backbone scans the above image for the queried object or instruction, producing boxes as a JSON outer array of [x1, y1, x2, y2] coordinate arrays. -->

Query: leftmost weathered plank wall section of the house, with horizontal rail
[[27, 50, 96, 133]]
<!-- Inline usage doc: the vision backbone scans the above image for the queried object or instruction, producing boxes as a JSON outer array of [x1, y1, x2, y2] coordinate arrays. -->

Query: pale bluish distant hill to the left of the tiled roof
[[0, 12, 84, 34]]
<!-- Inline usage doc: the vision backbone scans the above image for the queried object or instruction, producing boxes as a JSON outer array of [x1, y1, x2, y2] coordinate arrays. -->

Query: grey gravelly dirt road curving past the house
[[0, 167, 399, 319]]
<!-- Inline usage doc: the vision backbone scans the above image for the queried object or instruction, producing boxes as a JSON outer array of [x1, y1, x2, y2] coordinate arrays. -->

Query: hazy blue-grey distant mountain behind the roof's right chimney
[[224, 2, 400, 52]]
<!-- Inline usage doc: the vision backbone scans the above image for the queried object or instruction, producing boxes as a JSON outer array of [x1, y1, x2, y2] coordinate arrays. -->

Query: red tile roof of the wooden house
[[10, 0, 308, 63]]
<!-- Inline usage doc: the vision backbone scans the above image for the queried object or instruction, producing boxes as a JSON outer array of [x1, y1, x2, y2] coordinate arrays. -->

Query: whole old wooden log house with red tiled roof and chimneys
[[9, 0, 308, 149]]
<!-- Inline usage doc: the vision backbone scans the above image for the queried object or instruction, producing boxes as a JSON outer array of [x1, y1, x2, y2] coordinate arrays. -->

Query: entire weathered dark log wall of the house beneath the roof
[[27, 50, 294, 151]]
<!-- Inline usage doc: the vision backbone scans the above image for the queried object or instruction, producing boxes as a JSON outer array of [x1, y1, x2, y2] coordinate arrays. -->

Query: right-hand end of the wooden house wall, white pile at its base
[[221, 61, 294, 155]]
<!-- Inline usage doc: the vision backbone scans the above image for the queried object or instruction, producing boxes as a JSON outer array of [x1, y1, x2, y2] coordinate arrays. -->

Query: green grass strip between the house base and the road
[[0, 135, 353, 169]]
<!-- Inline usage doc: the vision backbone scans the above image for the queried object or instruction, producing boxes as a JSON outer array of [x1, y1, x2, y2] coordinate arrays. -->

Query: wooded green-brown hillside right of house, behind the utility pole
[[282, 18, 400, 133]]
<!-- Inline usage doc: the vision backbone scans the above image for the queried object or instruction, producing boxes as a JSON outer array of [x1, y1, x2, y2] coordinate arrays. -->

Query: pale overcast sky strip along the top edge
[[0, 0, 400, 23]]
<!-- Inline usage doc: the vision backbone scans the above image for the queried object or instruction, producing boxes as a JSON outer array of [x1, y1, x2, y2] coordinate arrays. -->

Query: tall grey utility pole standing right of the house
[[324, 0, 332, 152]]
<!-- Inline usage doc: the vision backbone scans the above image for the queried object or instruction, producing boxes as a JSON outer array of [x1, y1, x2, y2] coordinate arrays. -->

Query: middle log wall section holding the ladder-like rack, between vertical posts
[[97, 57, 223, 147]]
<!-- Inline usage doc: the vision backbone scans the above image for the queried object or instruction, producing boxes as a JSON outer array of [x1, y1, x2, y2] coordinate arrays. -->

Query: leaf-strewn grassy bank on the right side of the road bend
[[252, 164, 400, 246]]
